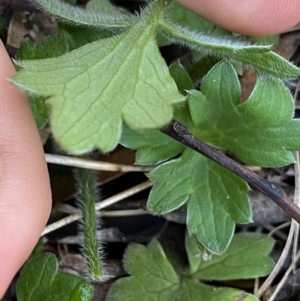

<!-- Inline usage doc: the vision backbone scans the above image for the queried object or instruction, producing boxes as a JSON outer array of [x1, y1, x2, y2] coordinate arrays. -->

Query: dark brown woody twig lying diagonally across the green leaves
[[161, 121, 300, 223]]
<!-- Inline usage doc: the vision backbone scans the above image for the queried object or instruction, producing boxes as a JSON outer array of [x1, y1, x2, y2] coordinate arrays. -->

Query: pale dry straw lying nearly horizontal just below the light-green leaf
[[45, 154, 153, 172]]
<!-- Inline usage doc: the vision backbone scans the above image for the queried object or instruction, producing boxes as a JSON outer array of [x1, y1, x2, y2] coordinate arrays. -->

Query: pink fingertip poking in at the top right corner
[[178, 0, 300, 36]]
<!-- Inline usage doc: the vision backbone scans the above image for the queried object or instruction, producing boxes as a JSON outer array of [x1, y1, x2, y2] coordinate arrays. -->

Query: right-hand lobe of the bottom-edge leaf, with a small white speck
[[186, 233, 274, 280]]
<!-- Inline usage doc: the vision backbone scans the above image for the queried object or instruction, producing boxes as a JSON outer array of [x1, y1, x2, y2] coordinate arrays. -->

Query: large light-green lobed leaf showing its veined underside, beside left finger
[[13, 14, 183, 154]]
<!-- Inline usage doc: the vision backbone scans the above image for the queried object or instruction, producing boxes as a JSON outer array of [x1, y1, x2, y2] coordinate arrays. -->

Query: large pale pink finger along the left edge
[[0, 41, 51, 298]]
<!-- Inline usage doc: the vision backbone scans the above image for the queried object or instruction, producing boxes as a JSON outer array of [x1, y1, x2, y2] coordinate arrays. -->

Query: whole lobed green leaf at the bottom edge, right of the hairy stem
[[107, 233, 273, 301]]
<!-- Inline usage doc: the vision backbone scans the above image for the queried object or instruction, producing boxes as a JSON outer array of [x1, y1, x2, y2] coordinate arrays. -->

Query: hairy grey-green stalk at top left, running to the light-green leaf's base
[[33, 0, 132, 28]]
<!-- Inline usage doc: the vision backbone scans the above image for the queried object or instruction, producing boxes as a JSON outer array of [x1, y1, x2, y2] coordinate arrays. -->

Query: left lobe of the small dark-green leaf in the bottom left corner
[[17, 254, 57, 301]]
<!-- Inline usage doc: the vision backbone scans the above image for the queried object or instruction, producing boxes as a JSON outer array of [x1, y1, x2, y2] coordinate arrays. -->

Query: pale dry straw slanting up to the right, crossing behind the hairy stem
[[41, 181, 153, 236]]
